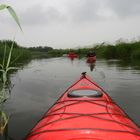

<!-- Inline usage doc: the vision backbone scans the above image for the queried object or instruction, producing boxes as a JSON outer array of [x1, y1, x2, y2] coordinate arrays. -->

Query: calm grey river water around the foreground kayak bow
[[1, 58, 140, 140]]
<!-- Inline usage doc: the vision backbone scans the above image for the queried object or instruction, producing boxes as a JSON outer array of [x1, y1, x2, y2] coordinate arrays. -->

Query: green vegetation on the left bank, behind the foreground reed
[[0, 40, 53, 66]]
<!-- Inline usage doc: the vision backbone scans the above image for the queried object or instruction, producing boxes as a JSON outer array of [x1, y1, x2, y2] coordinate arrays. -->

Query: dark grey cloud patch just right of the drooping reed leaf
[[20, 5, 65, 25]]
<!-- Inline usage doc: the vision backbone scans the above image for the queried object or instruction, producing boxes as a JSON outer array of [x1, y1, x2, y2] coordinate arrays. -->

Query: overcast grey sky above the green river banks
[[0, 0, 140, 48]]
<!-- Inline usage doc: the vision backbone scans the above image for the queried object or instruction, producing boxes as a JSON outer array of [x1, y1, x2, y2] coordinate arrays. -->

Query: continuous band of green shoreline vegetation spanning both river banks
[[0, 40, 140, 65]]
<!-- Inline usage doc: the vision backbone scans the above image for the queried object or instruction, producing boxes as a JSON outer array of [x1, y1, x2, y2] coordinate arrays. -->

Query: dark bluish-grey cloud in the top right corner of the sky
[[107, 0, 140, 18]]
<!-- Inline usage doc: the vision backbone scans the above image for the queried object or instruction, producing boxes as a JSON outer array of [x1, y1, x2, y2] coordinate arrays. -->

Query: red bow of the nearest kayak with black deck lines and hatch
[[26, 73, 140, 140]]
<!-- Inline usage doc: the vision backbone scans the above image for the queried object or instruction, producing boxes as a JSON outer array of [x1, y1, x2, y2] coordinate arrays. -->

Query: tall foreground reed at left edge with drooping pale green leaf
[[0, 4, 22, 135]]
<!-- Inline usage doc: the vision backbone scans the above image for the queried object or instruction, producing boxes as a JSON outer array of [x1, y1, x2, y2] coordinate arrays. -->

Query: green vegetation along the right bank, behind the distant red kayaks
[[48, 41, 140, 60]]
